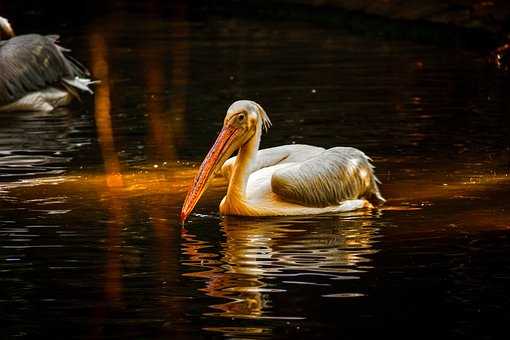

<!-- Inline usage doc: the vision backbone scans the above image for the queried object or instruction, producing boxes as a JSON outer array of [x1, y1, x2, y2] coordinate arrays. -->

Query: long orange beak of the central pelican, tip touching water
[[180, 126, 238, 223]]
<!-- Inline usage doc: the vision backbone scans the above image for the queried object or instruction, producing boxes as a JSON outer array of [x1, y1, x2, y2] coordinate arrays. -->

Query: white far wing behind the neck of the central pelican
[[221, 144, 325, 179]]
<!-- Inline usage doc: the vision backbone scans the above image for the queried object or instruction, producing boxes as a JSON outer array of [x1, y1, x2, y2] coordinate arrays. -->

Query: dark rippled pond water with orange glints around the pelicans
[[0, 1, 510, 339]]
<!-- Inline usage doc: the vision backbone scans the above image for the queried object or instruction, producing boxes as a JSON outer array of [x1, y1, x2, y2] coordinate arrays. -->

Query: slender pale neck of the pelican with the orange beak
[[225, 123, 262, 202]]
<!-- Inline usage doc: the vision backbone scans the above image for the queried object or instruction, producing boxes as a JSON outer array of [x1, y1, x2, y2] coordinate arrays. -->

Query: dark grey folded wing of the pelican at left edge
[[0, 34, 89, 106]]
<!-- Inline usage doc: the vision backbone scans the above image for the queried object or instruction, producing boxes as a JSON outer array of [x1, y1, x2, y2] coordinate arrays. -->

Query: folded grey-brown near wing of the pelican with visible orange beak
[[271, 147, 385, 207]]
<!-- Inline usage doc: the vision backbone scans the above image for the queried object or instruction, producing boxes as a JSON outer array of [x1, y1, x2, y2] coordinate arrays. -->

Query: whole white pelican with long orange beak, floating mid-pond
[[180, 100, 385, 222]]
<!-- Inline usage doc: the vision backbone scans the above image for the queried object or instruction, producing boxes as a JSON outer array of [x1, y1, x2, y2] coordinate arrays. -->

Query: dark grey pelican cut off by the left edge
[[0, 17, 93, 111]]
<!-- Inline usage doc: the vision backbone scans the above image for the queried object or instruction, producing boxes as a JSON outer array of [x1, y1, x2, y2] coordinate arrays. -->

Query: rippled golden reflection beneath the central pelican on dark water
[[183, 213, 378, 319]]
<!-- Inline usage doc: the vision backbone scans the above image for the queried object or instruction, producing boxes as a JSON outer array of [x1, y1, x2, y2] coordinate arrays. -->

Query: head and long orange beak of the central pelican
[[180, 100, 271, 222]]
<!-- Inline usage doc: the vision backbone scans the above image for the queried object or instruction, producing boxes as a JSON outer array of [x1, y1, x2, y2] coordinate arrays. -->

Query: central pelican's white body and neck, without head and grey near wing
[[220, 110, 378, 216]]
